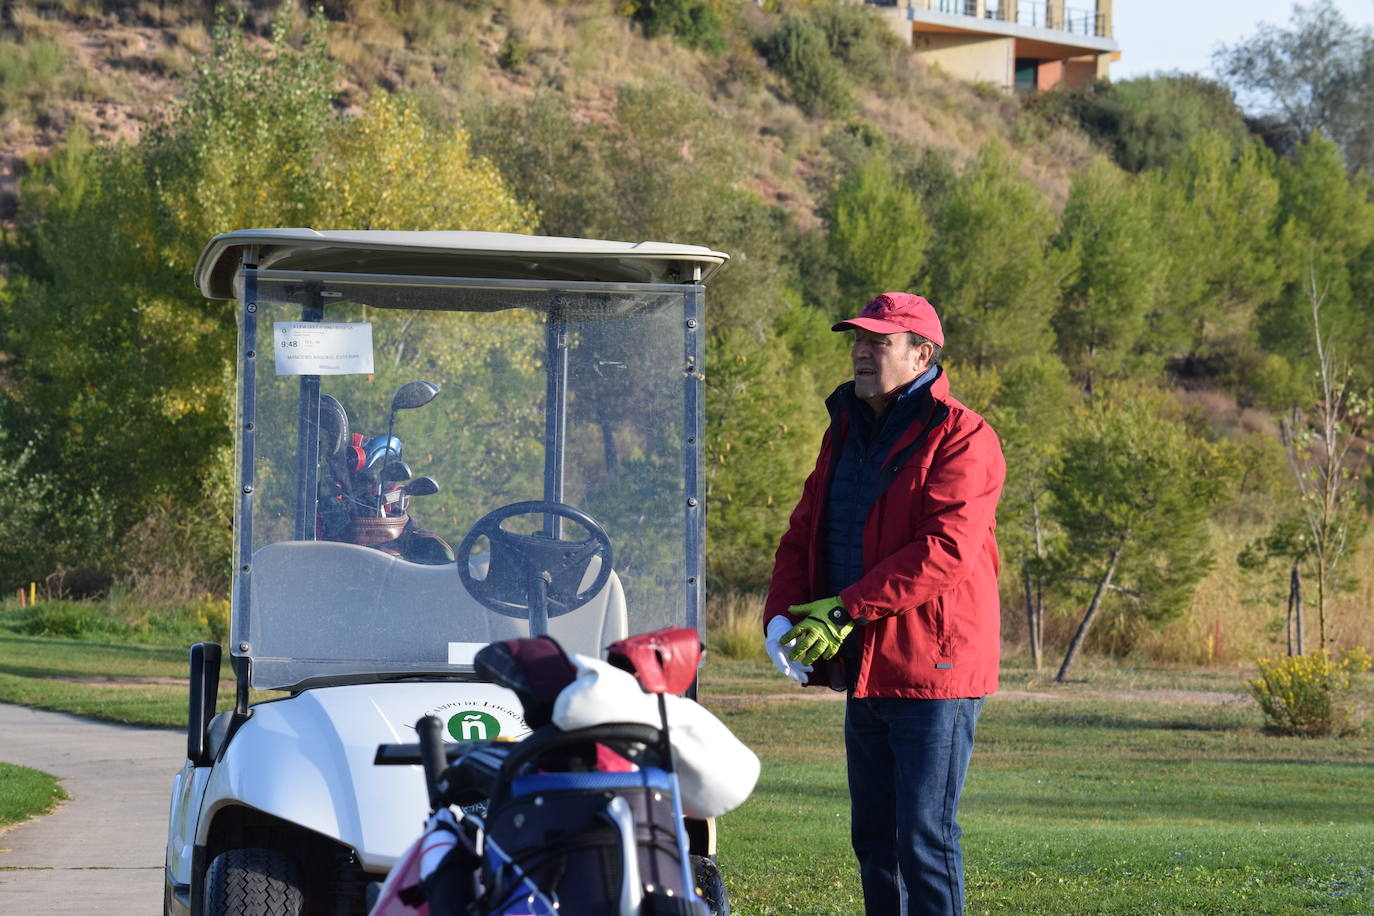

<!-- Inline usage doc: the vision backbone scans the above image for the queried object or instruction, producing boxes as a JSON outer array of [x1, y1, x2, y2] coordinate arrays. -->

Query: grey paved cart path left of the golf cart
[[0, 703, 185, 916]]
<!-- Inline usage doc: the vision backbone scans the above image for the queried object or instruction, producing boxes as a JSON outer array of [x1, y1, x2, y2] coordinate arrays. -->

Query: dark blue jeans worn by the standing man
[[845, 694, 982, 916]]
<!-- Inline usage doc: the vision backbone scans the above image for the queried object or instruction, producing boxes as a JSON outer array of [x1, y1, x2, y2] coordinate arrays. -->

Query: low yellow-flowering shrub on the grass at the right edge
[[1248, 647, 1370, 737]]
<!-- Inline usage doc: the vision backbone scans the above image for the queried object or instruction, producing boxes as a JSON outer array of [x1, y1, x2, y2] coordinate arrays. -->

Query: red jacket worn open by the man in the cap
[[764, 372, 1006, 699]]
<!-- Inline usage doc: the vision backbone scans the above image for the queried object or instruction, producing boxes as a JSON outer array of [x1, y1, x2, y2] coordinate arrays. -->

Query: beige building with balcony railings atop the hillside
[[868, 0, 1121, 92]]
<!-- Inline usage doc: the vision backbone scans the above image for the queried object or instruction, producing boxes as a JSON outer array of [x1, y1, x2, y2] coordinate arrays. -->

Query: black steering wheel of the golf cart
[[458, 500, 611, 623]]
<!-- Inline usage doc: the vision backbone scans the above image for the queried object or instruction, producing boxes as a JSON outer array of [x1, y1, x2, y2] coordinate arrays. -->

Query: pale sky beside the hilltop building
[[1110, 0, 1374, 80]]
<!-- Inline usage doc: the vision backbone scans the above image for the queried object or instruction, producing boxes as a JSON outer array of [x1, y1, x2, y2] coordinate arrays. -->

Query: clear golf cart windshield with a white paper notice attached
[[232, 269, 702, 688]]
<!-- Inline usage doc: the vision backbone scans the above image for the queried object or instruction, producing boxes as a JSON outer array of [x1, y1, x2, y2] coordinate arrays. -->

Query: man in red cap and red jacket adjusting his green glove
[[764, 293, 1006, 916]]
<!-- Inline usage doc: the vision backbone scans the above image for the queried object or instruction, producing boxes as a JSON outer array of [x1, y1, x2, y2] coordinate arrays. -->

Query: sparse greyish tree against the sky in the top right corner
[[1215, 0, 1374, 170]]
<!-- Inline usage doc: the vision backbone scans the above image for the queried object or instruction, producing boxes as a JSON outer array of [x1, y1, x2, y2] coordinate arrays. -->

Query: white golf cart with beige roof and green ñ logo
[[164, 229, 727, 916]]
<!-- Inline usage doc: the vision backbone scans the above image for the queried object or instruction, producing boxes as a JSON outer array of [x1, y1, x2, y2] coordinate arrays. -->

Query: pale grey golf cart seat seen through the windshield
[[249, 541, 629, 687]]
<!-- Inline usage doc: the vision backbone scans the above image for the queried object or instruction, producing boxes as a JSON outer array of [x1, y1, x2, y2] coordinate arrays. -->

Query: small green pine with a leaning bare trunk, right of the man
[[1050, 394, 1237, 683]]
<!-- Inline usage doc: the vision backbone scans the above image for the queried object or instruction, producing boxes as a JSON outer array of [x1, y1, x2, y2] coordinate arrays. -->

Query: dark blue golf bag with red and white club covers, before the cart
[[372, 630, 757, 916]]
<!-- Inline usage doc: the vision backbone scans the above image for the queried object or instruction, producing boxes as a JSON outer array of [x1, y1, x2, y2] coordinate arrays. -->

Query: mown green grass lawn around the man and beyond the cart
[[0, 626, 1374, 916]]
